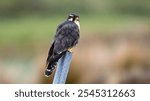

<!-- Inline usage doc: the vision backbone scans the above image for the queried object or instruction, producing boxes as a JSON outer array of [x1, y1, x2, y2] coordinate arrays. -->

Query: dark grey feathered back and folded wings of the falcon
[[54, 21, 79, 54]]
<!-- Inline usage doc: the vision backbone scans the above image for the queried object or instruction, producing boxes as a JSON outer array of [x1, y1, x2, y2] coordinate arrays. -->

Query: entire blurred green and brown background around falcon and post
[[0, 0, 150, 84]]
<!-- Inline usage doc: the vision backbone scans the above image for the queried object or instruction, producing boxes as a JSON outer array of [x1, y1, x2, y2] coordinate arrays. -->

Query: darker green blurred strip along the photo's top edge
[[0, 0, 150, 17]]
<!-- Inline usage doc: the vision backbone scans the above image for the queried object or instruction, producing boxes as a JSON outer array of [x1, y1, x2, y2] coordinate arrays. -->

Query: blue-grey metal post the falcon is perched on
[[53, 51, 72, 84]]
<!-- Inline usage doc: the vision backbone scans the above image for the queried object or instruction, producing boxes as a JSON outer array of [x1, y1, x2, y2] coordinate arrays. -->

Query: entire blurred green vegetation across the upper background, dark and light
[[0, 0, 150, 44]]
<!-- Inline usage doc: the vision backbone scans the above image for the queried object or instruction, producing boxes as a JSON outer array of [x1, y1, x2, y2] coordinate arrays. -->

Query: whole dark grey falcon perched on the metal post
[[45, 14, 80, 77]]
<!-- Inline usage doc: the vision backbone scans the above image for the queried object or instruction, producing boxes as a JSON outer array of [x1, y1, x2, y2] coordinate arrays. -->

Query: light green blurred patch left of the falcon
[[0, 17, 56, 44]]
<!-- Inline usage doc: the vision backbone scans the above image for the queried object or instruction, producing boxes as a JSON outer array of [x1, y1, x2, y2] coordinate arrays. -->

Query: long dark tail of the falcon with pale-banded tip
[[45, 51, 66, 77]]
